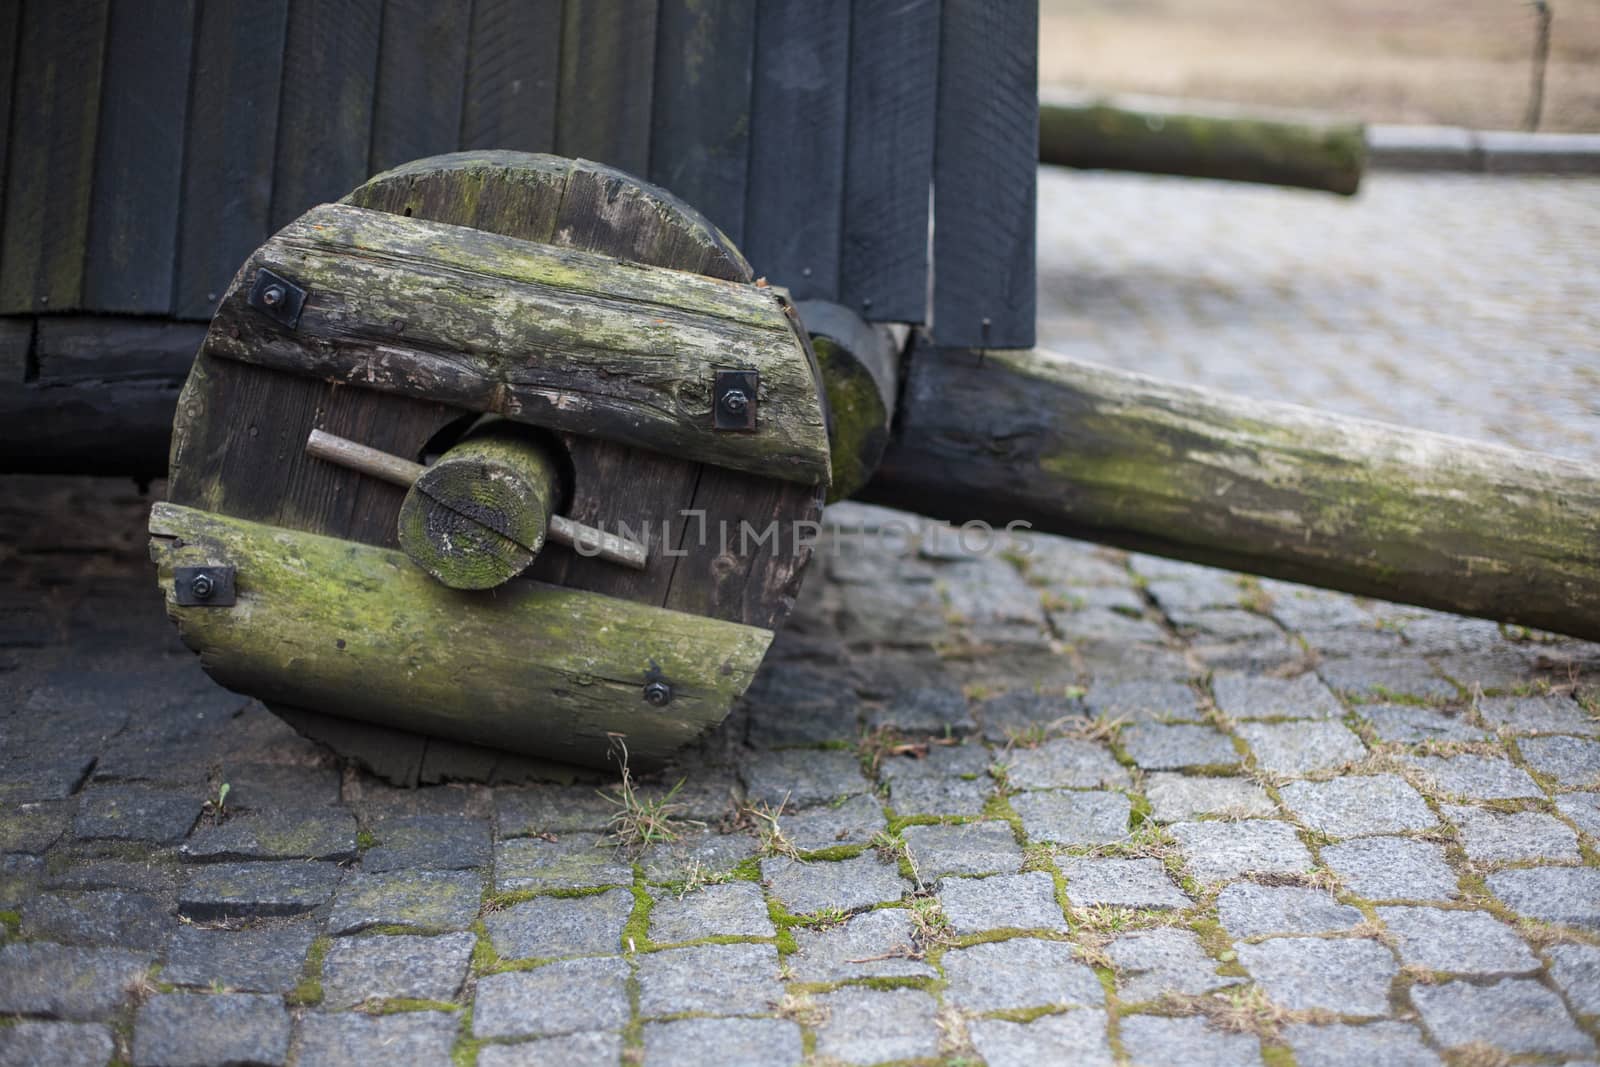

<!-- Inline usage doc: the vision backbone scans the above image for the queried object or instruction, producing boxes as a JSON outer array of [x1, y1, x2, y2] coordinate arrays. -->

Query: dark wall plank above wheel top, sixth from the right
[[461, 0, 562, 152]]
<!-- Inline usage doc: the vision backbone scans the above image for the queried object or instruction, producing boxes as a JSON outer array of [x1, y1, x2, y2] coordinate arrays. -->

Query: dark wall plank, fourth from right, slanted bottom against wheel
[[650, 0, 755, 245]]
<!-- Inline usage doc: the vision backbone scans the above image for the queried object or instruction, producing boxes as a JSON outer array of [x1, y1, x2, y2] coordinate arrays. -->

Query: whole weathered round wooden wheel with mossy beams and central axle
[[150, 152, 830, 784]]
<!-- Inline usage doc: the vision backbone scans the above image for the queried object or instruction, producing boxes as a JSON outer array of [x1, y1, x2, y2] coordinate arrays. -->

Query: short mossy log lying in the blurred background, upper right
[[1038, 91, 1366, 197]]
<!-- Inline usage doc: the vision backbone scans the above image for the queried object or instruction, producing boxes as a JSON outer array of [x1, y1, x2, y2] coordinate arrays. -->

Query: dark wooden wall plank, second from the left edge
[[83, 0, 195, 315]]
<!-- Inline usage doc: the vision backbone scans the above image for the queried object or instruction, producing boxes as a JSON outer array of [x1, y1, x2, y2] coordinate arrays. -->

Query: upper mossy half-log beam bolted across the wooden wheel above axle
[[206, 205, 829, 483]]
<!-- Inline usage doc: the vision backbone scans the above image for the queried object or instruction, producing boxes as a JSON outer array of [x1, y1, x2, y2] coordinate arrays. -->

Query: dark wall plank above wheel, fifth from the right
[[555, 0, 656, 178]]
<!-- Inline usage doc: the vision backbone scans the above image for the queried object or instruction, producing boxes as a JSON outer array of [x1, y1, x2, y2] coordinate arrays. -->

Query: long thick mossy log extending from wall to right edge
[[862, 347, 1600, 640]]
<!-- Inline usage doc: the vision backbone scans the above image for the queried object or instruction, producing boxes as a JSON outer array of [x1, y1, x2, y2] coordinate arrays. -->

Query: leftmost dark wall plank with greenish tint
[[0, 0, 109, 315]]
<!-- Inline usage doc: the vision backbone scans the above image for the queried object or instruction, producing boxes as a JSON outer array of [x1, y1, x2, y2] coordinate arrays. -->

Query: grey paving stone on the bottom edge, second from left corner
[[133, 993, 291, 1067]]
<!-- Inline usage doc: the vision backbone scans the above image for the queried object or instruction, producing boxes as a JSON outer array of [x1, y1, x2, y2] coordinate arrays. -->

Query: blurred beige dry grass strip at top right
[[1038, 0, 1600, 131]]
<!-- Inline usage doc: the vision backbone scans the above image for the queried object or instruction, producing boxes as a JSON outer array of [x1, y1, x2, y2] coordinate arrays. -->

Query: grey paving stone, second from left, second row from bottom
[[162, 921, 317, 993]]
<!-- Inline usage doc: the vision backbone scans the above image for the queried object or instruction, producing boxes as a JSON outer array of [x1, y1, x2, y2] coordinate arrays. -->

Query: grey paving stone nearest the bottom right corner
[[1411, 977, 1594, 1056]]
